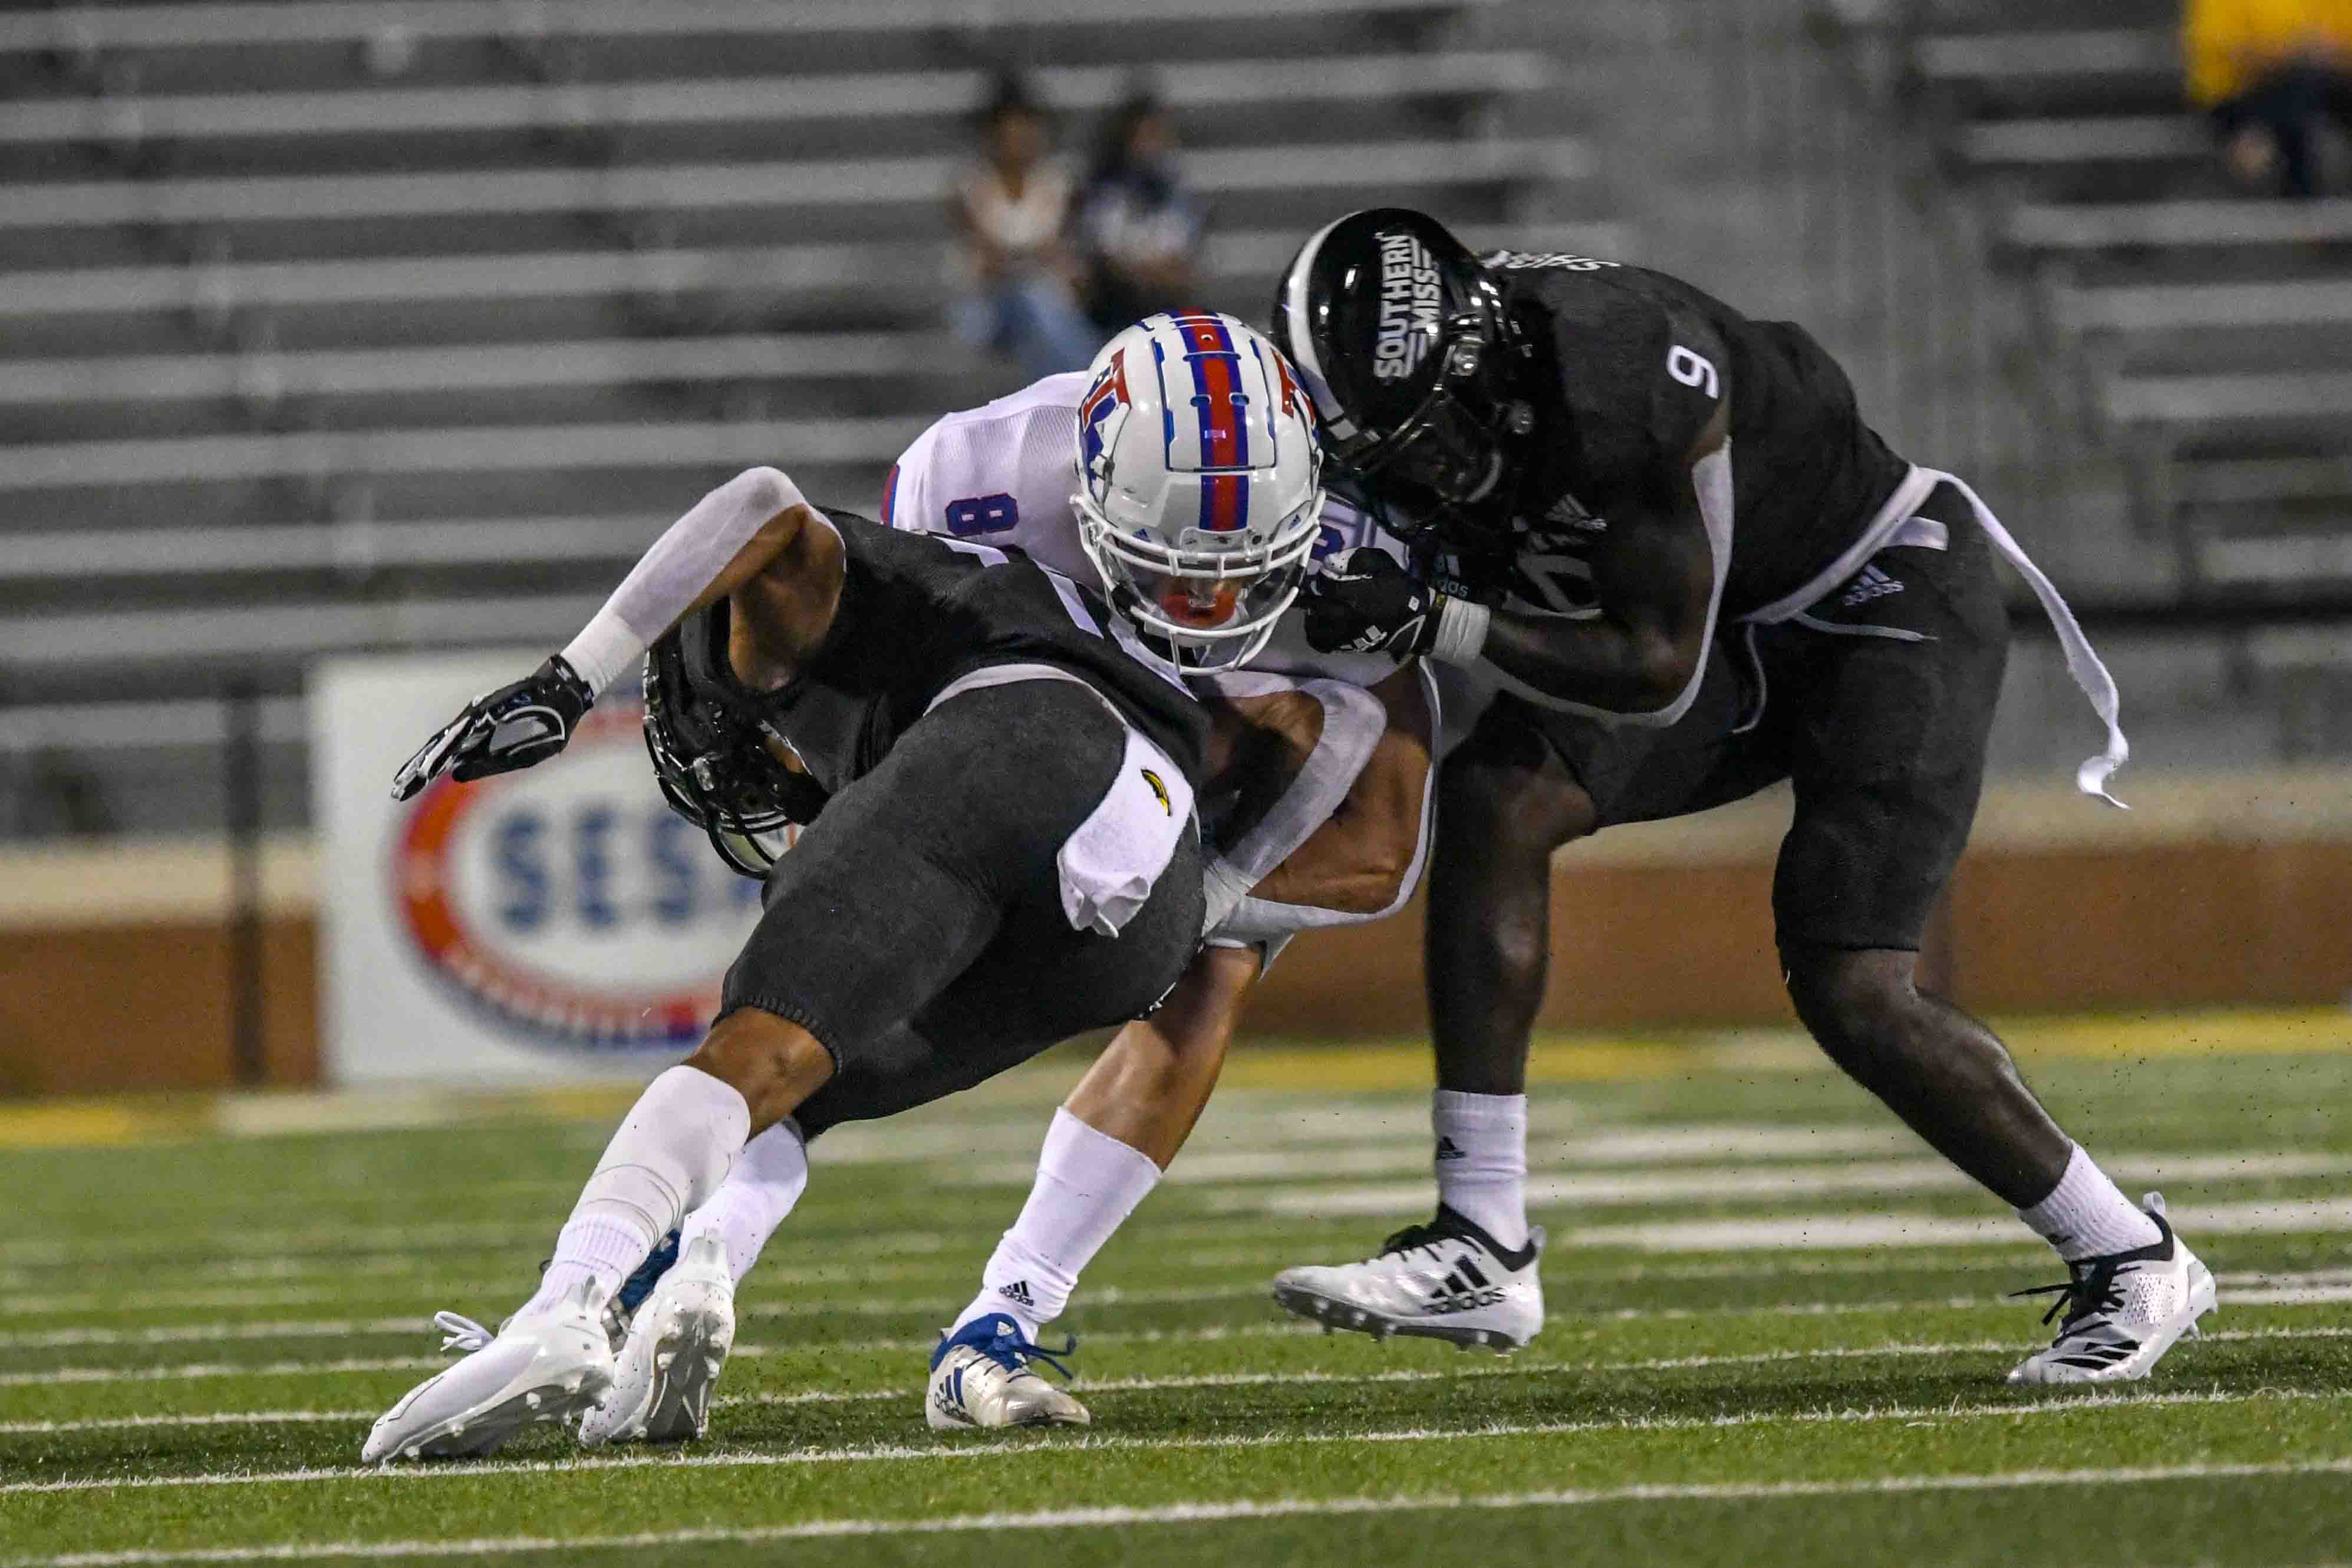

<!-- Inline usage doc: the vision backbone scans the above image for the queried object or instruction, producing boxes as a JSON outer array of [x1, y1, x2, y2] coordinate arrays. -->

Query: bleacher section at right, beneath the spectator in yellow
[[1908, 0, 2352, 599]]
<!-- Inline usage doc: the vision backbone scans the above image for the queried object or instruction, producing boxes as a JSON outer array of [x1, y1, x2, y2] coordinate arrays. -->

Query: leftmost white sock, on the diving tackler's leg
[[518, 1068, 750, 1316]]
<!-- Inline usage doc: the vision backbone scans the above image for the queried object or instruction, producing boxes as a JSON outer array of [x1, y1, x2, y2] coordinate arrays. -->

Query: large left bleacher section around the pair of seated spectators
[[0, 0, 1625, 828]]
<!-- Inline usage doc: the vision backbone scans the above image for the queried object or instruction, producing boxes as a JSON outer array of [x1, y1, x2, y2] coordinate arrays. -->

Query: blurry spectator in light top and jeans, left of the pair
[[948, 75, 1098, 381]]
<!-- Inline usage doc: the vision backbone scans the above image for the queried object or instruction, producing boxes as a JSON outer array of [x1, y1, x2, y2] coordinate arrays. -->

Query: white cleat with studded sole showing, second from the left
[[581, 1237, 734, 1448]]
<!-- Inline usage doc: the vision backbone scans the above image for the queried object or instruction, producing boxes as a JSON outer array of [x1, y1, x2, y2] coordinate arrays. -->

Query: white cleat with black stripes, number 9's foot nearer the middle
[[1275, 1204, 1543, 1354]]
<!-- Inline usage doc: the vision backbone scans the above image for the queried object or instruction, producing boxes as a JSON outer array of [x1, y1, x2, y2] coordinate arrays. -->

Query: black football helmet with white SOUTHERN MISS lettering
[[1275, 207, 1533, 531]]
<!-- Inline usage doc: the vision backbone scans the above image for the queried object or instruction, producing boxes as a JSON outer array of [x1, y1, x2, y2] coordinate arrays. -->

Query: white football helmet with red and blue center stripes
[[1070, 310, 1322, 675]]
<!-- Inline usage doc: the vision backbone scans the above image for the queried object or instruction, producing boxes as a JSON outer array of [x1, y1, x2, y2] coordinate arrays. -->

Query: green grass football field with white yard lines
[[0, 1018, 2352, 1568]]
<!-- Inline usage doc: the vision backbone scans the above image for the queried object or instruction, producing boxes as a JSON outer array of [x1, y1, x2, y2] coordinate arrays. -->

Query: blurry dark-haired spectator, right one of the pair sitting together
[[1077, 87, 1202, 331]]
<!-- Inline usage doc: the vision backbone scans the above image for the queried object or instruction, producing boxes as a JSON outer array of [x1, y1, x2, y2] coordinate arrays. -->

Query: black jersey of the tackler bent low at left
[[651, 508, 1207, 795]]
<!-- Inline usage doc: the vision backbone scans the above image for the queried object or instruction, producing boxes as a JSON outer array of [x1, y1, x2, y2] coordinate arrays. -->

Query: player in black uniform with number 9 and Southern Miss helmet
[[1275, 209, 2213, 1382]]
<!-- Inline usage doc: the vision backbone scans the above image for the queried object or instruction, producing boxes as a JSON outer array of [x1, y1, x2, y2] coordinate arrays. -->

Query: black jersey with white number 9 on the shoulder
[[1482, 252, 1910, 621]]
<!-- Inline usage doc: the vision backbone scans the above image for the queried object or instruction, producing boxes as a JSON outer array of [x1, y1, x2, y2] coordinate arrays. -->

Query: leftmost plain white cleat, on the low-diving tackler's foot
[[360, 1279, 611, 1465]]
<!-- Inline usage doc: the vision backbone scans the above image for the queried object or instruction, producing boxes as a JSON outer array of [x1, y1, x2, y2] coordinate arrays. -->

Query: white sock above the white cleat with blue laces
[[950, 1109, 1159, 1340]]
